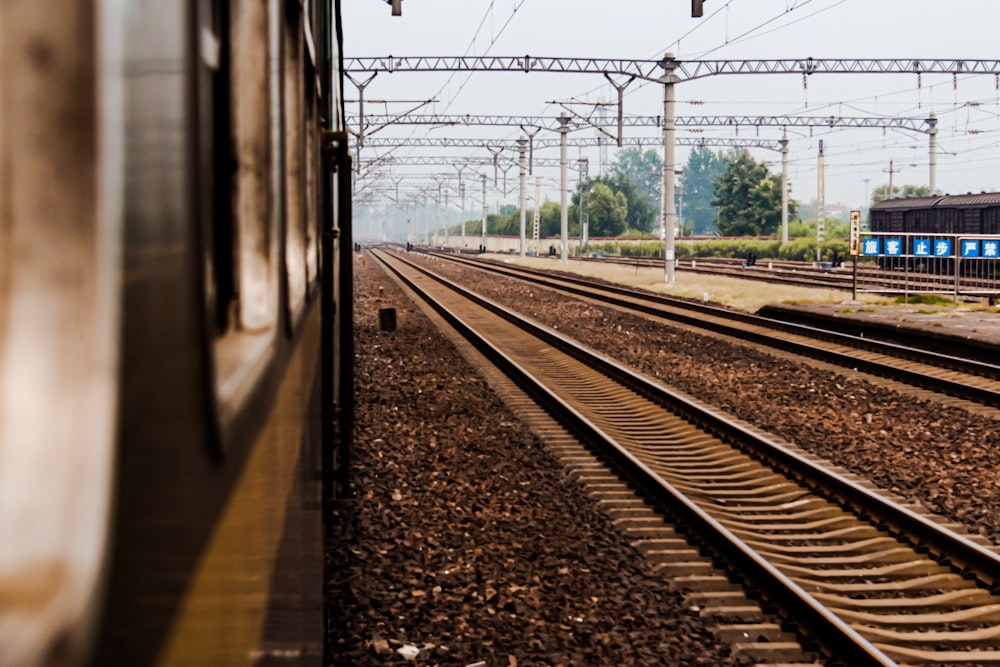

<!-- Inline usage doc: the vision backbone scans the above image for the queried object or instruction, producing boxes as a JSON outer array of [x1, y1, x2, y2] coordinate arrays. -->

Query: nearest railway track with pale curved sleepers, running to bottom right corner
[[377, 253, 1000, 665]]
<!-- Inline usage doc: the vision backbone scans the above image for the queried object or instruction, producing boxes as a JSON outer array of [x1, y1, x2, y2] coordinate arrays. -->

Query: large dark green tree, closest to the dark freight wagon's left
[[712, 149, 797, 236]]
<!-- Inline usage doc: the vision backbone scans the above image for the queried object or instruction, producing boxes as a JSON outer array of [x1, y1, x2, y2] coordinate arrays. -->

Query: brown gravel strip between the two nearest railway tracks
[[411, 255, 1000, 543]]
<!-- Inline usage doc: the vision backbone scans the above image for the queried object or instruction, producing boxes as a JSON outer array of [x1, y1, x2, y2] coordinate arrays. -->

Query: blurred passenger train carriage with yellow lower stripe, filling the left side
[[0, 0, 352, 667]]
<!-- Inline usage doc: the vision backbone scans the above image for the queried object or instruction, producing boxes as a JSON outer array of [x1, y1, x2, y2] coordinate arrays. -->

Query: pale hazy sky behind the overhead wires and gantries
[[343, 0, 1000, 208]]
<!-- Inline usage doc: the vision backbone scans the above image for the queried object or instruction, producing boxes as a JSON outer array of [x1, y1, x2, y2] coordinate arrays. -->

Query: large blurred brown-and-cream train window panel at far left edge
[[0, 0, 121, 665]]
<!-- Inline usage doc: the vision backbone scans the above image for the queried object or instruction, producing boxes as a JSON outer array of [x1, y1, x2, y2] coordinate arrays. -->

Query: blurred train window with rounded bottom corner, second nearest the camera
[[210, 0, 282, 425]]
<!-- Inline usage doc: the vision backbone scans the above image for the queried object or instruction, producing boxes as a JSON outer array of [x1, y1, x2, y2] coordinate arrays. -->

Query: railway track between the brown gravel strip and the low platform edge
[[418, 248, 1000, 408]]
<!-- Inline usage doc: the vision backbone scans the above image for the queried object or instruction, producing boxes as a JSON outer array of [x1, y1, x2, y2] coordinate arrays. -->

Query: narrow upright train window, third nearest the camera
[[283, 3, 308, 322]]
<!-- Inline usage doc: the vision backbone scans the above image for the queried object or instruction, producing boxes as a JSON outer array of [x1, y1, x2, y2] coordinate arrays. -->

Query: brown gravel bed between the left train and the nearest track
[[327, 253, 739, 667]]
